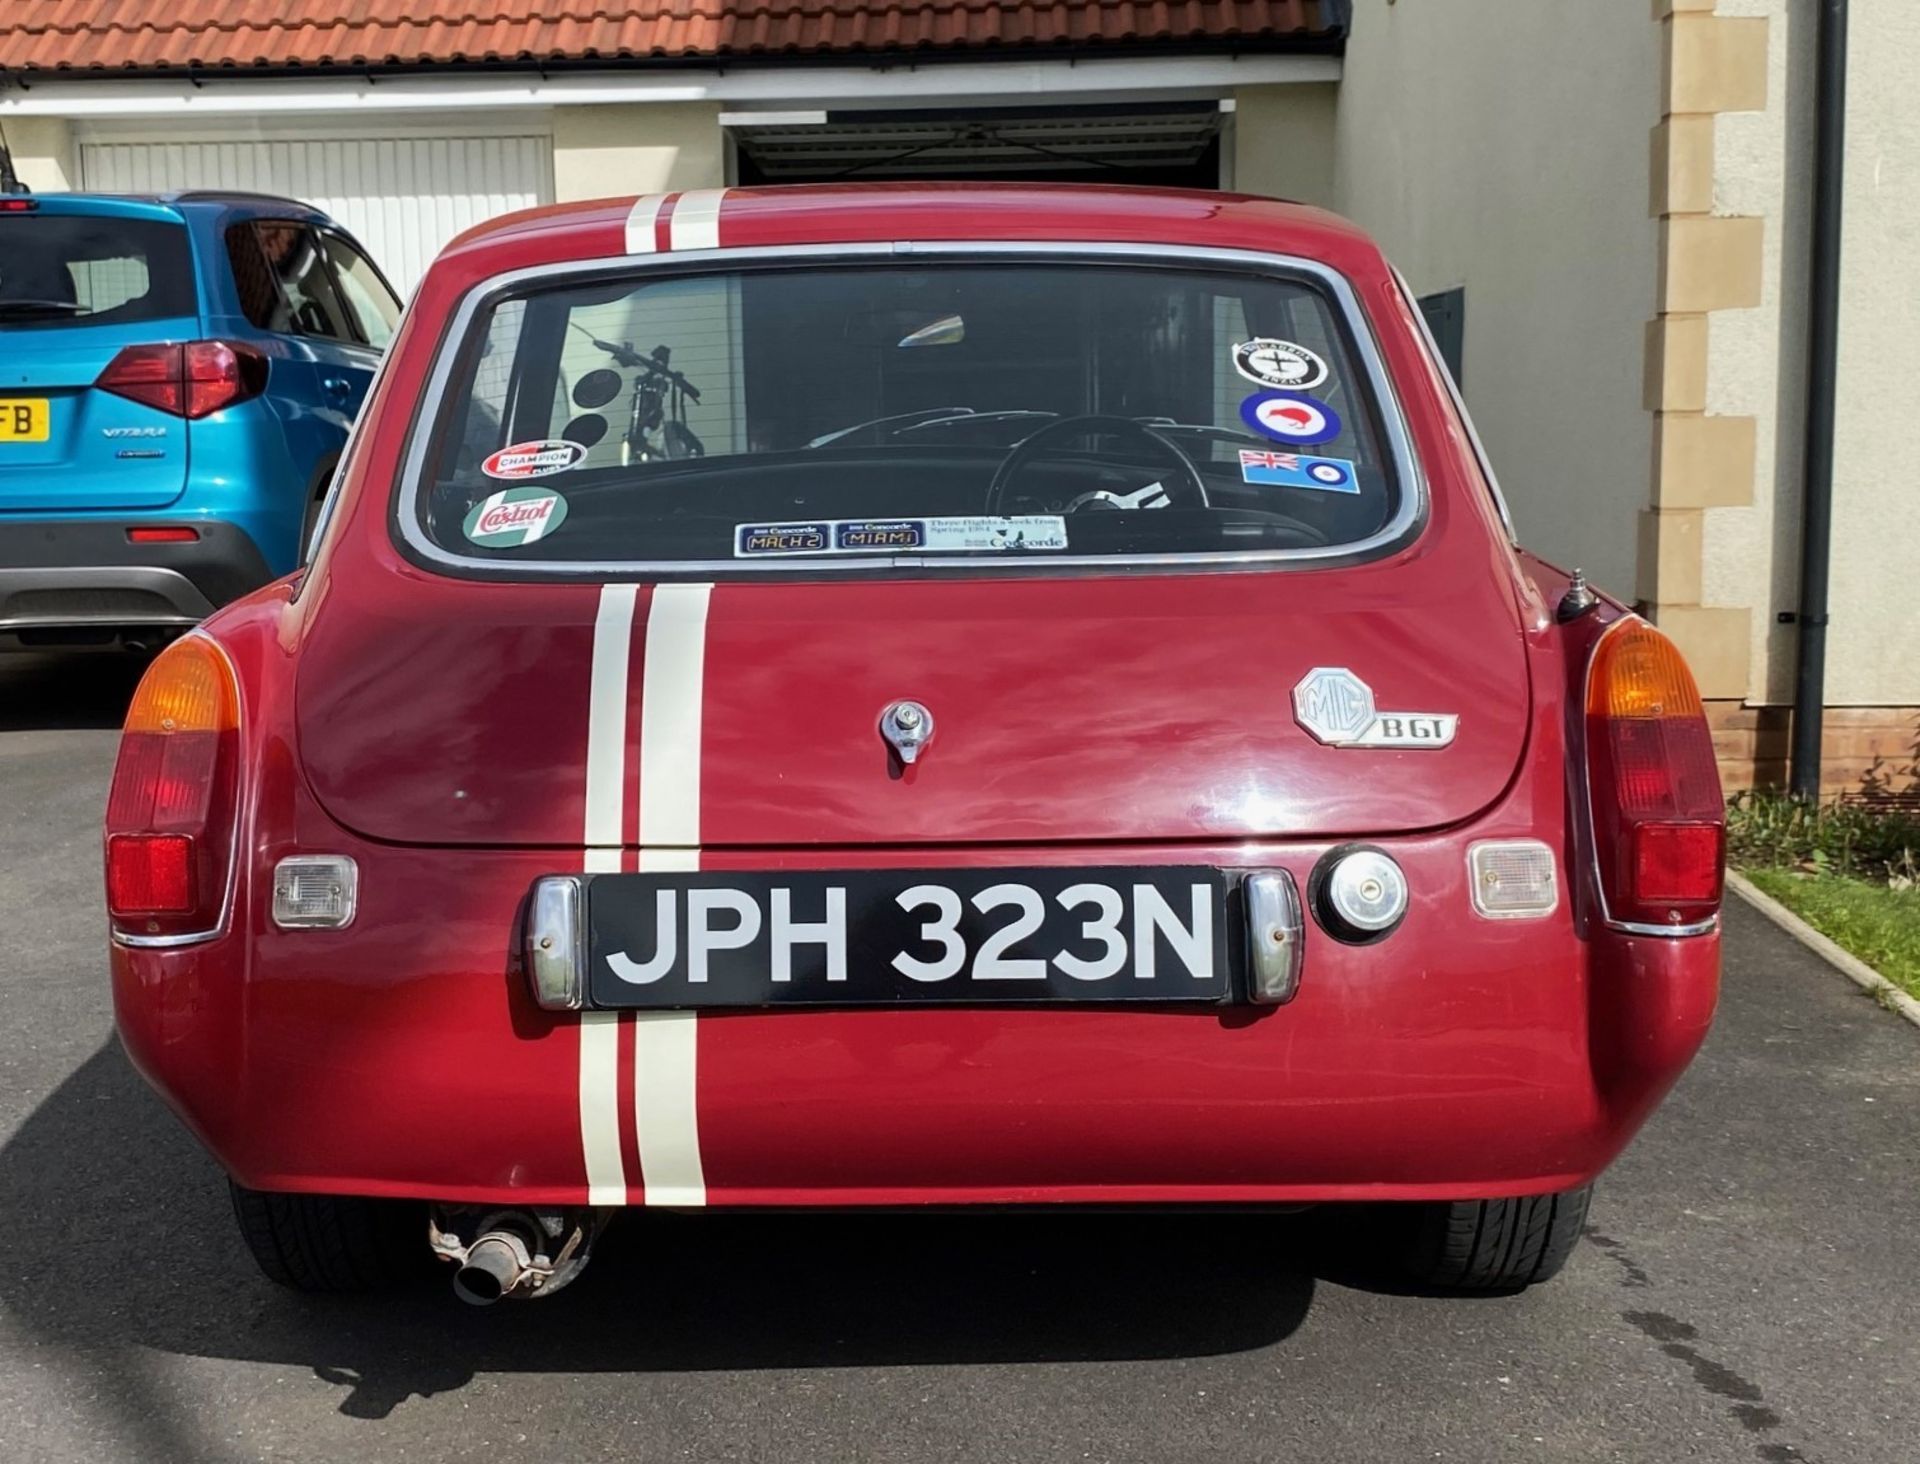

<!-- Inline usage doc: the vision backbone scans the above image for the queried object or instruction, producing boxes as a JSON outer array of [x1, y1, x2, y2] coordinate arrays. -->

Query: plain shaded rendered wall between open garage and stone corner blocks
[[1328, 0, 1661, 598]]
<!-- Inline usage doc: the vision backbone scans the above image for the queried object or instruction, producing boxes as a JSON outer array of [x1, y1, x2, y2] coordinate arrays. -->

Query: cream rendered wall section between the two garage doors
[[553, 102, 726, 204]]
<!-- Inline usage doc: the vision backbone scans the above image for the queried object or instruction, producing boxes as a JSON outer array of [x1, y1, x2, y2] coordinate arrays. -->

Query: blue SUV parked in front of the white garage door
[[0, 192, 399, 646]]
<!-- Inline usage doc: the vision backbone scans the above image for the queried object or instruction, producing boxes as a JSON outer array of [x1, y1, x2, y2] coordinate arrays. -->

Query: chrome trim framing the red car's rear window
[[392, 240, 1428, 582]]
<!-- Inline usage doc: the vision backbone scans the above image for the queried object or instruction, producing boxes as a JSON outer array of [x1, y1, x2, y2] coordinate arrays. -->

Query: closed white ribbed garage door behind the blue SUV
[[81, 134, 553, 294]]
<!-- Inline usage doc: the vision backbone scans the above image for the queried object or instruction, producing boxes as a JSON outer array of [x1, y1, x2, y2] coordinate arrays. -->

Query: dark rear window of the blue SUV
[[0, 213, 200, 330]]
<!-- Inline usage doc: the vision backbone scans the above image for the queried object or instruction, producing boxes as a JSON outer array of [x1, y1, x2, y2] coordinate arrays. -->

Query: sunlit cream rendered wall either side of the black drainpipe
[[1703, 0, 1920, 707]]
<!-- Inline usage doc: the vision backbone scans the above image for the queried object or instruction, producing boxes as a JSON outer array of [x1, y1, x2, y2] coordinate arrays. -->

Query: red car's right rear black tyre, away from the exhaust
[[1405, 1185, 1594, 1291]]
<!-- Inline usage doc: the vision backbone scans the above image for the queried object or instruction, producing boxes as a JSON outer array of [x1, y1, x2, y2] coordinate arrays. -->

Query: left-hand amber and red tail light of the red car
[[108, 636, 240, 938]]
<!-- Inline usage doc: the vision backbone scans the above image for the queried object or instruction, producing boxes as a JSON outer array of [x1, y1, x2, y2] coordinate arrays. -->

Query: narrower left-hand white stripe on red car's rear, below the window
[[580, 584, 637, 1205]]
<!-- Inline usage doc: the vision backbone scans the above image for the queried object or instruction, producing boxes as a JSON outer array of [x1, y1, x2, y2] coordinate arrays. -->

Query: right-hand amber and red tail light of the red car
[[1586, 619, 1726, 928]]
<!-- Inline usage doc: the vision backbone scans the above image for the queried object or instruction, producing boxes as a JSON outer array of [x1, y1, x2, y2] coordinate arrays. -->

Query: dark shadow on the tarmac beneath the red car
[[0, 1041, 1338, 1429]]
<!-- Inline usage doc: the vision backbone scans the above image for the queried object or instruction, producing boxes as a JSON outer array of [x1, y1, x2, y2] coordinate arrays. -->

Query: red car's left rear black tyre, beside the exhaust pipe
[[228, 1182, 432, 1291]]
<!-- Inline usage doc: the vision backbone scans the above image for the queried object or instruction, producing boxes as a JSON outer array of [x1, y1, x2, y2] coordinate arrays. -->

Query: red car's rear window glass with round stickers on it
[[409, 257, 1402, 573]]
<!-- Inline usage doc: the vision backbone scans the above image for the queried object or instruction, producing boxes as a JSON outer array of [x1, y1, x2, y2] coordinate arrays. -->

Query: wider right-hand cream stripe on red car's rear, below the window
[[634, 580, 712, 1205]]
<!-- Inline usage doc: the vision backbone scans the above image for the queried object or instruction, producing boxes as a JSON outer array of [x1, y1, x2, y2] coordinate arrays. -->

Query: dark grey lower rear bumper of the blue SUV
[[0, 517, 273, 634]]
